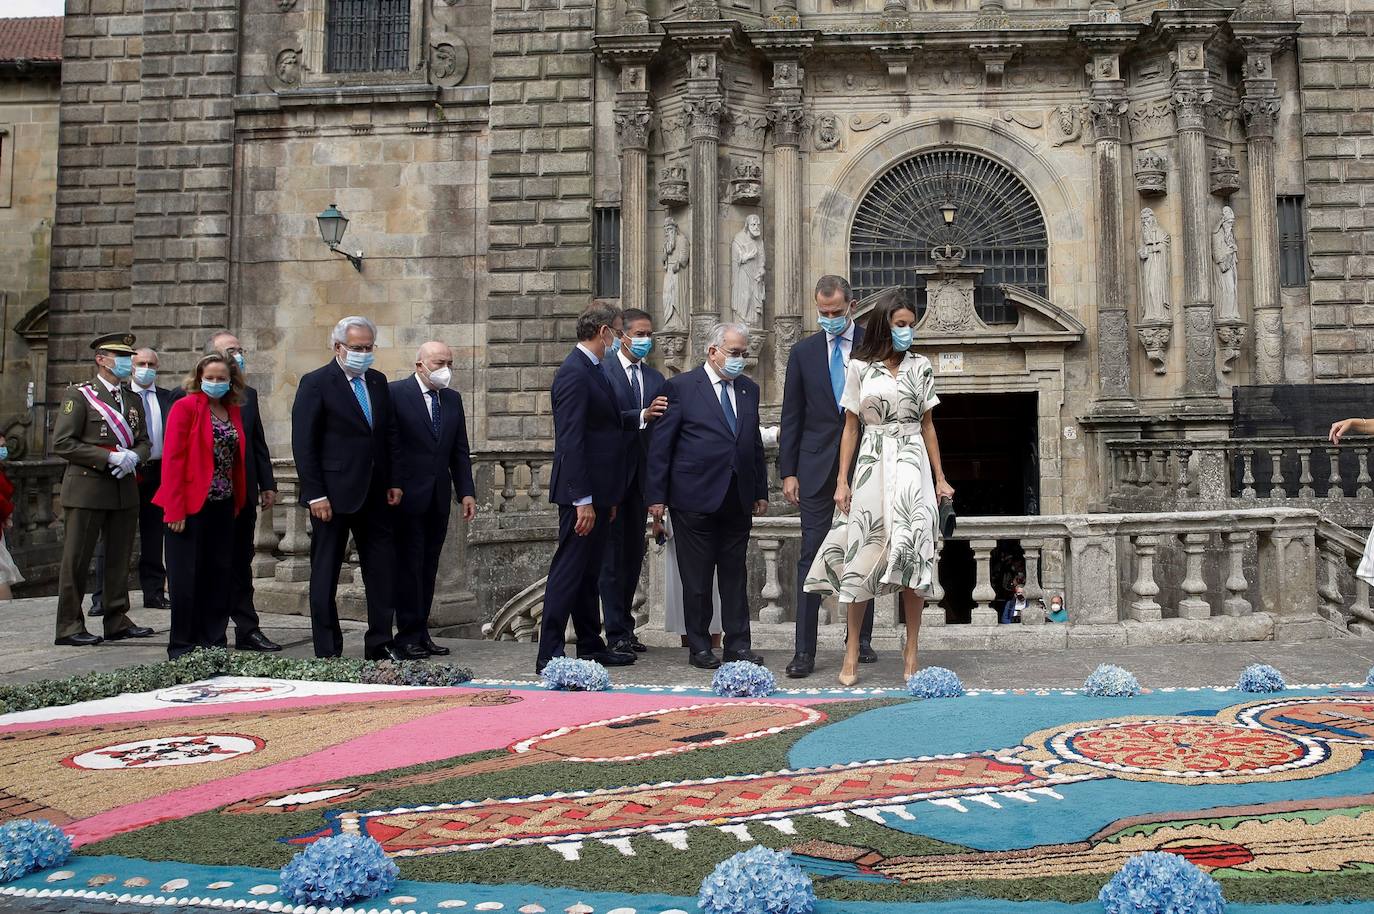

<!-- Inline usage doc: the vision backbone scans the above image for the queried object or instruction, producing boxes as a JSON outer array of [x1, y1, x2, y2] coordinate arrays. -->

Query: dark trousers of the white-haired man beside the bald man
[[311, 485, 396, 657]]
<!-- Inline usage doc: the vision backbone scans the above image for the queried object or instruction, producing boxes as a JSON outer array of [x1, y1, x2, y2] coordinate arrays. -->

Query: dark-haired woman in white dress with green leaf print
[[807, 290, 954, 686]]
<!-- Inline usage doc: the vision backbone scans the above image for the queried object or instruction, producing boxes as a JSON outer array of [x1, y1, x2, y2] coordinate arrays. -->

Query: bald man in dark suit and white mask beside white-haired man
[[392, 342, 477, 656]]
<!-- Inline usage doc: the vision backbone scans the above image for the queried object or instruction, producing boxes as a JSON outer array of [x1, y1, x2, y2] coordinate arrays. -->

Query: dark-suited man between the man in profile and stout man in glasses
[[599, 308, 668, 654]]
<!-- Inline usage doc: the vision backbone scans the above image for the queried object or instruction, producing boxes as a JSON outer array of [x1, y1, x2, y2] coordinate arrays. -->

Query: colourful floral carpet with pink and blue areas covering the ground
[[0, 678, 1374, 914]]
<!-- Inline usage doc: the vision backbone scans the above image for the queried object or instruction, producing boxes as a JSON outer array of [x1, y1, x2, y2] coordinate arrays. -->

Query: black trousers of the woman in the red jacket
[[166, 499, 234, 660]]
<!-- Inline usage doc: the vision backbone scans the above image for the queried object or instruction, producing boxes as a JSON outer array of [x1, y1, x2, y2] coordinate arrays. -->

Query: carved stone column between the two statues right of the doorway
[[1160, 10, 1224, 399]]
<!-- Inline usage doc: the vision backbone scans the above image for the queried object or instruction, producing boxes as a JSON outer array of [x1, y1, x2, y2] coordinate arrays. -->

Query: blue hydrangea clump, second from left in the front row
[[280, 834, 400, 907]]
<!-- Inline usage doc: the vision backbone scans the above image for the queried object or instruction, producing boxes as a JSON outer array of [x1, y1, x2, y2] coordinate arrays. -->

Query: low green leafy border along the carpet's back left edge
[[0, 647, 473, 713]]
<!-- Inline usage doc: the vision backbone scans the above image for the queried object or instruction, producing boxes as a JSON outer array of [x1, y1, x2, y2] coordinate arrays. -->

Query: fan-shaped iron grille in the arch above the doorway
[[849, 150, 1050, 323]]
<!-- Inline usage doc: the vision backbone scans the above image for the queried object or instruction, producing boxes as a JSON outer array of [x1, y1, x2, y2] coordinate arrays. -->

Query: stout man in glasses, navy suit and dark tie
[[646, 324, 768, 669]]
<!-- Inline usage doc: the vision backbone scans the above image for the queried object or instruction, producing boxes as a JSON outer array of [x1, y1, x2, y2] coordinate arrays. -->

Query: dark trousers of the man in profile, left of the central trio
[[539, 504, 610, 662]]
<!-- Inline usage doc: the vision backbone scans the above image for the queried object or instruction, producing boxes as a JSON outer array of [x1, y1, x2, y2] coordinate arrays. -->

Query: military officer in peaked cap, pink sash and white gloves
[[52, 333, 153, 647]]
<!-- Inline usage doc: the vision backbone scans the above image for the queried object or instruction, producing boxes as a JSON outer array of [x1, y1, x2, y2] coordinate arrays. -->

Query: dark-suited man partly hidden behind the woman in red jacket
[[205, 330, 282, 653]]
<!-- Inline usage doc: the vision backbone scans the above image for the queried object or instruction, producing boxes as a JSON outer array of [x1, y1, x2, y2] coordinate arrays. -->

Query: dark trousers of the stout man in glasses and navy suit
[[672, 480, 754, 654]]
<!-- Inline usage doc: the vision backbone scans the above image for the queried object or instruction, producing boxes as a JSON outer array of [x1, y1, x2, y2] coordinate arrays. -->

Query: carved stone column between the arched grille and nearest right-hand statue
[[1074, 22, 1140, 411]]
